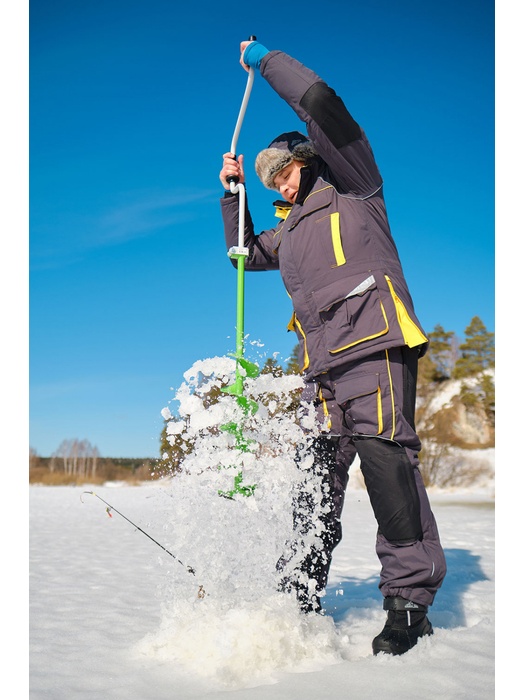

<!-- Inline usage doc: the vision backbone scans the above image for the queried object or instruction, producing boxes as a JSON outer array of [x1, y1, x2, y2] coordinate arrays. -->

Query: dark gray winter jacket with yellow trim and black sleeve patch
[[221, 51, 427, 379]]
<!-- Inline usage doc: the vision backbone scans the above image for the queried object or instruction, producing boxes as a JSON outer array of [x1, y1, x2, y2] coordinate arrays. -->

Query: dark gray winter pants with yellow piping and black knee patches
[[317, 347, 446, 605]]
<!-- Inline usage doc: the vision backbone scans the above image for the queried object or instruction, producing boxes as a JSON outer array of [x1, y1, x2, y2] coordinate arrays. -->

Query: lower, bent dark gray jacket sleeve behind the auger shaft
[[221, 193, 280, 271]]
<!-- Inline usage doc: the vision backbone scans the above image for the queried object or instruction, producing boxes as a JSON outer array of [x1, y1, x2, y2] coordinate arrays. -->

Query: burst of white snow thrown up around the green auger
[[137, 357, 348, 687]]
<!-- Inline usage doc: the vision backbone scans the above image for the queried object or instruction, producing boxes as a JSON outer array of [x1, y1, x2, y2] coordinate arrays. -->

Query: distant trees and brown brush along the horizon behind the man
[[29, 316, 496, 484]]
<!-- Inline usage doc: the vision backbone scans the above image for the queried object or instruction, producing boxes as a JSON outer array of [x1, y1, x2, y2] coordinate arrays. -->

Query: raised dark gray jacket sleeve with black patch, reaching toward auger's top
[[260, 51, 382, 197]]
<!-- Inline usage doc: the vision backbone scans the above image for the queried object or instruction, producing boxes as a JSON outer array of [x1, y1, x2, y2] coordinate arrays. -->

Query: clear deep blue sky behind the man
[[28, 0, 495, 457]]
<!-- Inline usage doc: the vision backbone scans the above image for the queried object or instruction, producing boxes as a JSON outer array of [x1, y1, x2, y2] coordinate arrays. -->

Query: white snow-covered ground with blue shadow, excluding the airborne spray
[[29, 483, 495, 700]]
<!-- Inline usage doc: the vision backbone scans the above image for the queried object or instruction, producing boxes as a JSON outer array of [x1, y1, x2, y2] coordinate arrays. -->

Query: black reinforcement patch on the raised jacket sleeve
[[300, 82, 361, 148]]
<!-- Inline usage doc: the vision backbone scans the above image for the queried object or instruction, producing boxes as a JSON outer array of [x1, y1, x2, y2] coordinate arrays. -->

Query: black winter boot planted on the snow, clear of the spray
[[372, 596, 434, 655]]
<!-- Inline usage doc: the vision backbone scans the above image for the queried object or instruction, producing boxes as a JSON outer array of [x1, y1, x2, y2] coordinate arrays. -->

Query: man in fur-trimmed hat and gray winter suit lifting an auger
[[220, 41, 446, 654]]
